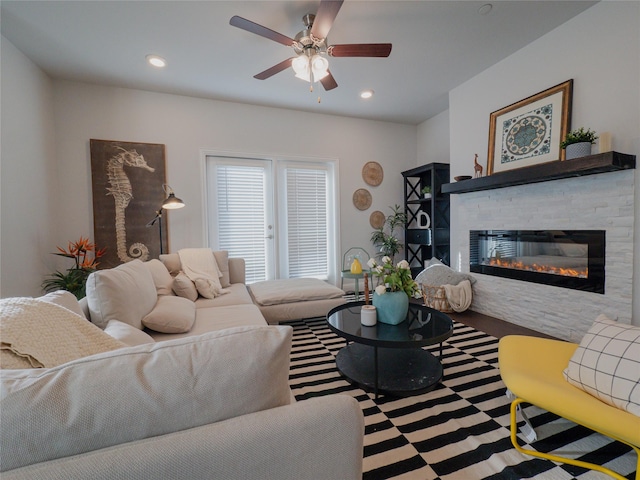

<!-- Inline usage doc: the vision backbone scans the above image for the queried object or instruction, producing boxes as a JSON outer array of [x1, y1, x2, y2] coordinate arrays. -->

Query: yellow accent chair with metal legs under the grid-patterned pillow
[[498, 335, 640, 480]]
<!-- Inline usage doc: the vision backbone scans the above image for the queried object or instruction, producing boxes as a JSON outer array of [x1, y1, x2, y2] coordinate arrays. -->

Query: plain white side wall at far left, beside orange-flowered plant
[[0, 37, 57, 297]]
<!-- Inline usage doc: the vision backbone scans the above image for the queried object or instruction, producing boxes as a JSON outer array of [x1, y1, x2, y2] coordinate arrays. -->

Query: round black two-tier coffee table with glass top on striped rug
[[327, 302, 453, 398]]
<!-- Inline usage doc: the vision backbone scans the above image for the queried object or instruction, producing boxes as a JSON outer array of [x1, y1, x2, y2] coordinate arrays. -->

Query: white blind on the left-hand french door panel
[[215, 165, 266, 283]]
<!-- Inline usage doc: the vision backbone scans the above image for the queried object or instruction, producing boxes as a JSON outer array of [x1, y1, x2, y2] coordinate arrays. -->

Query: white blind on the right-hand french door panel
[[285, 168, 329, 278]]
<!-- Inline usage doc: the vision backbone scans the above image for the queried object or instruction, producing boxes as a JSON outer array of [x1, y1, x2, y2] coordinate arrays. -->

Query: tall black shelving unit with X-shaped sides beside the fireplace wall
[[402, 163, 451, 276]]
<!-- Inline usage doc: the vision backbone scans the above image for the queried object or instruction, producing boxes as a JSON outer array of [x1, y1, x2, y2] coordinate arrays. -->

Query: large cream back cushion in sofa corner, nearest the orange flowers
[[87, 260, 158, 329]]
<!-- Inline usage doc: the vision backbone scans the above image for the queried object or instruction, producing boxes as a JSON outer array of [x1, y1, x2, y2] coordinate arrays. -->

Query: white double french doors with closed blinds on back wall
[[206, 155, 338, 283]]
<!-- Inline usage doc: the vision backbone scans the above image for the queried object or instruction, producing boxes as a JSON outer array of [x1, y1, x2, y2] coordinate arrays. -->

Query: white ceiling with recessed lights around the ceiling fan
[[0, 0, 596, 124]]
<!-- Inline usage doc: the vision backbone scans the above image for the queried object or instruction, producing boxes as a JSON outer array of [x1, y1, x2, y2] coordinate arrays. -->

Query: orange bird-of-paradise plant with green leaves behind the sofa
[[42, 237, 106, 299]]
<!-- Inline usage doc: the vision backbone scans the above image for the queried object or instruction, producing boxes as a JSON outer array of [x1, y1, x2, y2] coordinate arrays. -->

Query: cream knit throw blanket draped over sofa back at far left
[[0, 297, 126, 369]]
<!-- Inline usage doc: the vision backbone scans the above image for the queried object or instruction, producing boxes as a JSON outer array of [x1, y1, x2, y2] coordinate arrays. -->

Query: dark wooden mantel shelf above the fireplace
[[442, 152, 636, 193]]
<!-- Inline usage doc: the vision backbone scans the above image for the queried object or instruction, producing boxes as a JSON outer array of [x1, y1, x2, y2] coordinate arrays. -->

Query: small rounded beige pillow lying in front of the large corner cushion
[[142, 296, 196, 333]]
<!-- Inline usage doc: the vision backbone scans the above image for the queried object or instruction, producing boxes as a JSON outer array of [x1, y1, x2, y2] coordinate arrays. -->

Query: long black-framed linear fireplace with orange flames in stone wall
[[469, 230, 605, 293]]
